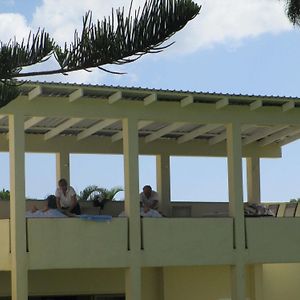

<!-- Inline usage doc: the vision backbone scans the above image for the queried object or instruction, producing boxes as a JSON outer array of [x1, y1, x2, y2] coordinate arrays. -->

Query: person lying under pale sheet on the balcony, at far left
[[26, 195, 66, 218]]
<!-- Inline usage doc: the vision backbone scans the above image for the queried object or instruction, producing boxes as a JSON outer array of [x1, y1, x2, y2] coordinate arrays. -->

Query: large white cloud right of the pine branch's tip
[[174, 0, 292, 52]]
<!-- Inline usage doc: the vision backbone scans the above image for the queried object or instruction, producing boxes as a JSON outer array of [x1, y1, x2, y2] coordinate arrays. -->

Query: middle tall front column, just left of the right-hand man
[[123, 119, 142, 300]]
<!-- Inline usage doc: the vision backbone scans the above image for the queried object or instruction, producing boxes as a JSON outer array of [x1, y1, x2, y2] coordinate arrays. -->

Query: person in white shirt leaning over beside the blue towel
[[55, 178, 81, 215]]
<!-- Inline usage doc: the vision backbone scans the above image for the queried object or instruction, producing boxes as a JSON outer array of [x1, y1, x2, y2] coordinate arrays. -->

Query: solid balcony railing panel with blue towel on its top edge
[[27, 218, 128, 269]]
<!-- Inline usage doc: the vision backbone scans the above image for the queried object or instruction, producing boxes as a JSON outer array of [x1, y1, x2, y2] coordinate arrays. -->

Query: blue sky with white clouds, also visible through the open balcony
[[0, 0, 300, 201]]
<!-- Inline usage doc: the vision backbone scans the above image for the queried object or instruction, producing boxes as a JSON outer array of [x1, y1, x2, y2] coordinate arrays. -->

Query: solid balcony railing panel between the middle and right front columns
[[142, 218, 233, 266]]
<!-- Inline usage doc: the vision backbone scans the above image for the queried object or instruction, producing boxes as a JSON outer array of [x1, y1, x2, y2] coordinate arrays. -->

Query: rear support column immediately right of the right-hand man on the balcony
[[156, 154, 171, 216]]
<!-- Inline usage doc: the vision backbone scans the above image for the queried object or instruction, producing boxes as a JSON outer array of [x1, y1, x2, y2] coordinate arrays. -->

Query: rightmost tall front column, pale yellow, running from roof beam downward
[[227, 124, 246, 300]]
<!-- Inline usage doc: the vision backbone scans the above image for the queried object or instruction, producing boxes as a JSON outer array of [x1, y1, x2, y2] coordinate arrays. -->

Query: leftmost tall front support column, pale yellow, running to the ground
[[9, 114, 28, 300]]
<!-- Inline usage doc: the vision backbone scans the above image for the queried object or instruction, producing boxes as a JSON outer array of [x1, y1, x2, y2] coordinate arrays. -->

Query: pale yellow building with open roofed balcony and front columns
[[0, 82, 300, 300]]
